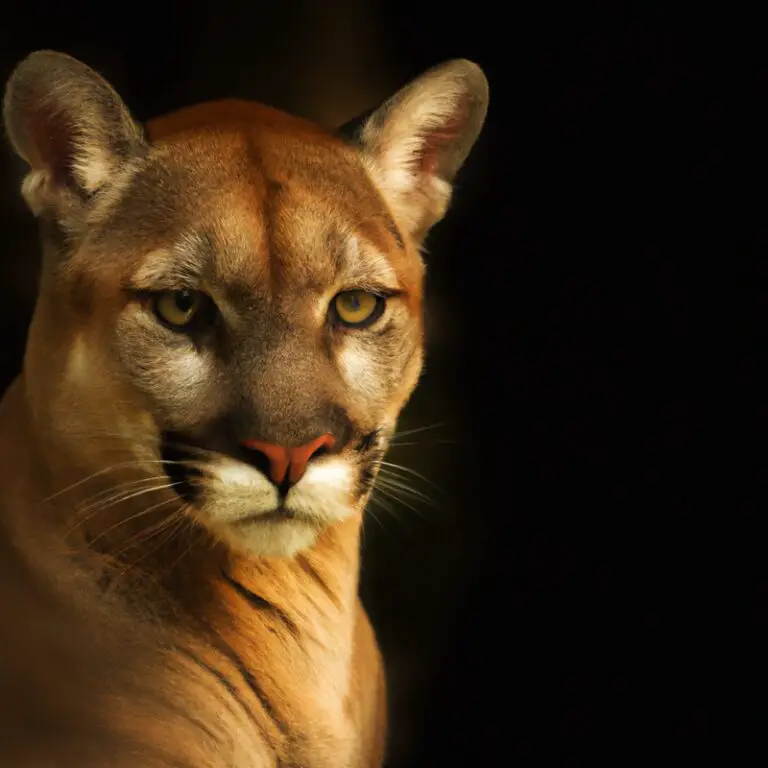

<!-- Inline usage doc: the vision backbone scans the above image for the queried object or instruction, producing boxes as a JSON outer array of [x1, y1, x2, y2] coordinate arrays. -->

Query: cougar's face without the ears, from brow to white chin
[[106, 121, 422, 552]]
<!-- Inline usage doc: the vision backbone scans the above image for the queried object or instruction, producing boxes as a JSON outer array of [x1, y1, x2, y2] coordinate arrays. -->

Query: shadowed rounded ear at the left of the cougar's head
[[3, 51, 147, 223]]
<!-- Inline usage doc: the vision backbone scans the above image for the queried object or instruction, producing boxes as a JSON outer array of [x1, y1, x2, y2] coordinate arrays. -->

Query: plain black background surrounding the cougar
[[0, 0, 768, 768]]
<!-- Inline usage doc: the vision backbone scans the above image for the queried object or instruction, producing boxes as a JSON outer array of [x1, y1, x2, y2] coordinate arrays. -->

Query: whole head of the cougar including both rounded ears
[[5, 52, 487, 555]]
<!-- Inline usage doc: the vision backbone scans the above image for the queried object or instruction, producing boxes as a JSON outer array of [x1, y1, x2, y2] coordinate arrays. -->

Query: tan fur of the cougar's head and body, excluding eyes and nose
[[0, 52, 487, 768]]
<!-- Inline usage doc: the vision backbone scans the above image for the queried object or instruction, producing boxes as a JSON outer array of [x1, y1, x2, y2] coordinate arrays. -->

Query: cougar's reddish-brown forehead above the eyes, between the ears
[[83, 101, 422, 310]]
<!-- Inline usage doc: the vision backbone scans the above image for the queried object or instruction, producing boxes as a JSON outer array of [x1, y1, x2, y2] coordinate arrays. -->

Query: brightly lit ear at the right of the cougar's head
[[341, 59, 488, 242]]
